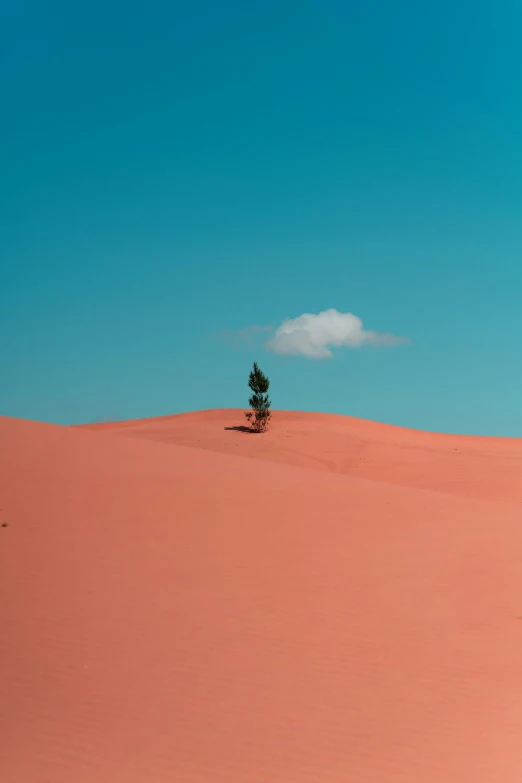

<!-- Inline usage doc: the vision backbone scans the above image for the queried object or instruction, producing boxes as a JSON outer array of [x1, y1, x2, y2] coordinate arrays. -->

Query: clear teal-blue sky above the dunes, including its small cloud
[[0, 0, 522, 437]]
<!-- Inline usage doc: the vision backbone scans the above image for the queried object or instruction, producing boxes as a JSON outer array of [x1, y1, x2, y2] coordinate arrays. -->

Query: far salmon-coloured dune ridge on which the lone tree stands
[[82, 409, 522, 504]]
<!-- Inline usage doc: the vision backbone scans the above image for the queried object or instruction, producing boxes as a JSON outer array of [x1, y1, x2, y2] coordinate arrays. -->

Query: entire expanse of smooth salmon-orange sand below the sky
[[0, 412, 522, 783]]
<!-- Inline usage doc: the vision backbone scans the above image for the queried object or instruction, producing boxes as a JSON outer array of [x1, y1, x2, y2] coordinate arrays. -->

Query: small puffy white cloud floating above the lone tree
[[266, 308, 407, 359]]
